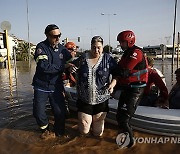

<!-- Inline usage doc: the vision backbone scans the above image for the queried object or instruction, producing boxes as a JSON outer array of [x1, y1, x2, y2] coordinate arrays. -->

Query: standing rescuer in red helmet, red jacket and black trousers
[[116, 30, 148, 148]]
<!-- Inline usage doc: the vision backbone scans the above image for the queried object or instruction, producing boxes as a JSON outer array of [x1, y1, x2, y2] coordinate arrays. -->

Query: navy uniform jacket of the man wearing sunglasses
[[32, 40, 72, 91]]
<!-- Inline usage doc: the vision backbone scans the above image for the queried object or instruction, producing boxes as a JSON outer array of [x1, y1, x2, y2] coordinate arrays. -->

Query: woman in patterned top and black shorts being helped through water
[[69, 36, 117, 136]]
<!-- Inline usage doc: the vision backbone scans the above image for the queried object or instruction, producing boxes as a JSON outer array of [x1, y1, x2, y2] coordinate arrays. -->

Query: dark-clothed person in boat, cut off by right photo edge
[[169, 68, 180, 109]]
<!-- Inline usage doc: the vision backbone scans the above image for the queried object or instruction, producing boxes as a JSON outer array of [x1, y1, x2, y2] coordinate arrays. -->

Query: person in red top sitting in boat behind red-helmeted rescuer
[[139, 57, 169, 108]]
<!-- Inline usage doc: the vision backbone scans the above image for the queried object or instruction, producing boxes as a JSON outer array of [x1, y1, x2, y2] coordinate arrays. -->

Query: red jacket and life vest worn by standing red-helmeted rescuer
[[119, 46, 148, 86]]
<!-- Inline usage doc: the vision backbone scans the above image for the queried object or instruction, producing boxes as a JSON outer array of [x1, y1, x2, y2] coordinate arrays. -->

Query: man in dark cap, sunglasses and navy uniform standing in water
[[32, 24, 71, 139]]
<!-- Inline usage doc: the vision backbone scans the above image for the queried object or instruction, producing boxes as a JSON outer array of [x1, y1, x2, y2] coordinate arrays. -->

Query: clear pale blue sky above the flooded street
[[0, 0, 180, 49]]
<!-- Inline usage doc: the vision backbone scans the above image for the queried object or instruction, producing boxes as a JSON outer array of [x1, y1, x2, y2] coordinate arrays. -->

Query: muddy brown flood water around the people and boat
[[0, 60, 180, 154]]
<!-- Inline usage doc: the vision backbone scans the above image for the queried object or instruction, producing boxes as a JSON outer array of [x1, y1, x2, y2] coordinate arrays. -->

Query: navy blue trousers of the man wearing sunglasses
[[33, 89, 65, 135]]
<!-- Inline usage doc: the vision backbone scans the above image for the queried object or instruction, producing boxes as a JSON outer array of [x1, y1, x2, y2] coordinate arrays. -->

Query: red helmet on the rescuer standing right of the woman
[[117, 30, 135, 48]]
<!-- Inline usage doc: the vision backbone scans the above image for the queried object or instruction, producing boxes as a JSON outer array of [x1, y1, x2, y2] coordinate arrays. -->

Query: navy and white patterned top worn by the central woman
[[73, 53, 117, 105]]
